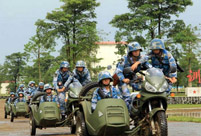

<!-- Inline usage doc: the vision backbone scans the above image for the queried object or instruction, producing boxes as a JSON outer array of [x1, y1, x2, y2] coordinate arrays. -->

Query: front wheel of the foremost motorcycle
[[154, 111, 168, 136]]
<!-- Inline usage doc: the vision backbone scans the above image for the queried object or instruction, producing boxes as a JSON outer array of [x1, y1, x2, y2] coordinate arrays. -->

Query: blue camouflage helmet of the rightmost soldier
[[149, 39, 165, 50]]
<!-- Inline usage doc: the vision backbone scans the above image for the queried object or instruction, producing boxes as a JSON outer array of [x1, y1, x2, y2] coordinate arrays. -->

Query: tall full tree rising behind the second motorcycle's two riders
[[40, 0, 100, 78]]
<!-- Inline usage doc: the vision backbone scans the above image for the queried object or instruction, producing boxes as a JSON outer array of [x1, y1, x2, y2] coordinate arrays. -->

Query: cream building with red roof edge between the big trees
[[94, 41, 126, 75]]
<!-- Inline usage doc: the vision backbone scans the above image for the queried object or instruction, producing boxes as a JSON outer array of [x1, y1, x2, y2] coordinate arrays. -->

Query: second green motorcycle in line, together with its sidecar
[[30, 78, 82, 135]]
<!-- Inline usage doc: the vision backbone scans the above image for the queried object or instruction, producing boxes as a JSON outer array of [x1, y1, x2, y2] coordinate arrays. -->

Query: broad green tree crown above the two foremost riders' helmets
[[110, 0, 192, 55]]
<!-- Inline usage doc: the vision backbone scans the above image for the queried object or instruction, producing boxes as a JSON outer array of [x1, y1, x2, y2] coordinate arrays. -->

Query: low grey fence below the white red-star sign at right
[[168, 97, 201, 104]]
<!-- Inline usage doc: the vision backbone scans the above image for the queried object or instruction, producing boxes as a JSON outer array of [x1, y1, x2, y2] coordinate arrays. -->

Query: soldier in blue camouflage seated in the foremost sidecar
[[91, 71, 120, 111]]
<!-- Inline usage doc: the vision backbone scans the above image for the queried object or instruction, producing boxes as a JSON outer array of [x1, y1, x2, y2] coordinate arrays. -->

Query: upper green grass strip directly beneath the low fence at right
[[168, 104, 201, 109]]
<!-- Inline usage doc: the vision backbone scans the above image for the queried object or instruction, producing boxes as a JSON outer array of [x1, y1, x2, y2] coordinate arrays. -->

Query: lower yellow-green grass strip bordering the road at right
[[168, 116, 201, 123]]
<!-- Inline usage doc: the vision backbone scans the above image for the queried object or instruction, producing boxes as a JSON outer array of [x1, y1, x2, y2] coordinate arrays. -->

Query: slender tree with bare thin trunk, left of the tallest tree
[[24, 20, 56, 81]]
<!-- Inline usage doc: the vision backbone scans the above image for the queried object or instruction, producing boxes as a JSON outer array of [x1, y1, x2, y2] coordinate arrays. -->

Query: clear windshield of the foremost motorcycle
[[145, 67, 165, 89]]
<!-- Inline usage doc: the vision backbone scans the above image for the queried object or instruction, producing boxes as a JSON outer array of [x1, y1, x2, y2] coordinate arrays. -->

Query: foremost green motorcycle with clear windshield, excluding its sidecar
[[124, 67, 169, 136]]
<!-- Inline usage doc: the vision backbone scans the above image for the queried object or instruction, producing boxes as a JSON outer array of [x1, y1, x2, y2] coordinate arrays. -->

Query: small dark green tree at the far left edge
[[4, 52, 28, 91]]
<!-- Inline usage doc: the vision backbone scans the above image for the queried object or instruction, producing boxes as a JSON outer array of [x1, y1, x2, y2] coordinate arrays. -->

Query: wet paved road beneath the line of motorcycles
[[0, 100, 201, 136]]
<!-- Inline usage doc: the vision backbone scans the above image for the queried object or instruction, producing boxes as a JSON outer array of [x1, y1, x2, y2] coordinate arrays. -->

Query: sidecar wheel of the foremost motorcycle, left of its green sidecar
[[76, 112, 88, 136]]
